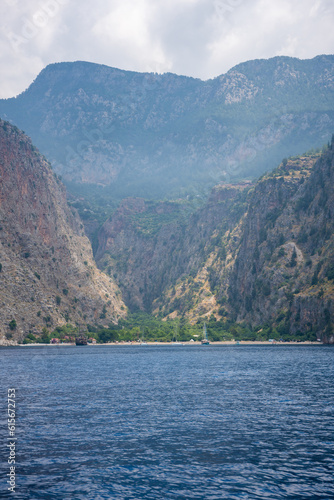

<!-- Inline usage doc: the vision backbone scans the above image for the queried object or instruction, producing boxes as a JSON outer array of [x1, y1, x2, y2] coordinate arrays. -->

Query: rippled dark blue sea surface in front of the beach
[[0, 345, 334, 500]]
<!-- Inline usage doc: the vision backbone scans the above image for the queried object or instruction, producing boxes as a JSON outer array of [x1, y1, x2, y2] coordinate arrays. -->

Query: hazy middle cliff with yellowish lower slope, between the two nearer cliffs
[[96, 183, 249, 319]]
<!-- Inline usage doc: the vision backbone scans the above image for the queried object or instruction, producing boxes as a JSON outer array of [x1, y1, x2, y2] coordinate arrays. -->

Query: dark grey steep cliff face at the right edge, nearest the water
[[229, 142, 334, 341]]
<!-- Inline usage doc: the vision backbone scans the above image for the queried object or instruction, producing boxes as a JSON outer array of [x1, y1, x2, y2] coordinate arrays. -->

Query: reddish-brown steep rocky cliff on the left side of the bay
[[0, 120, 125, 343]]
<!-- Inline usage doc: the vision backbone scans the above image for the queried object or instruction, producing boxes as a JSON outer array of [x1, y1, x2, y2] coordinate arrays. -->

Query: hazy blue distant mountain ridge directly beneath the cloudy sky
[[0, 55, 334, 199]]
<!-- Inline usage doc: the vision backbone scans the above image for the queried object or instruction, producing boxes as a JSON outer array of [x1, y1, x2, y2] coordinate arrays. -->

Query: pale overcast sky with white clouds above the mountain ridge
[[0, 0, 334, 97]]
